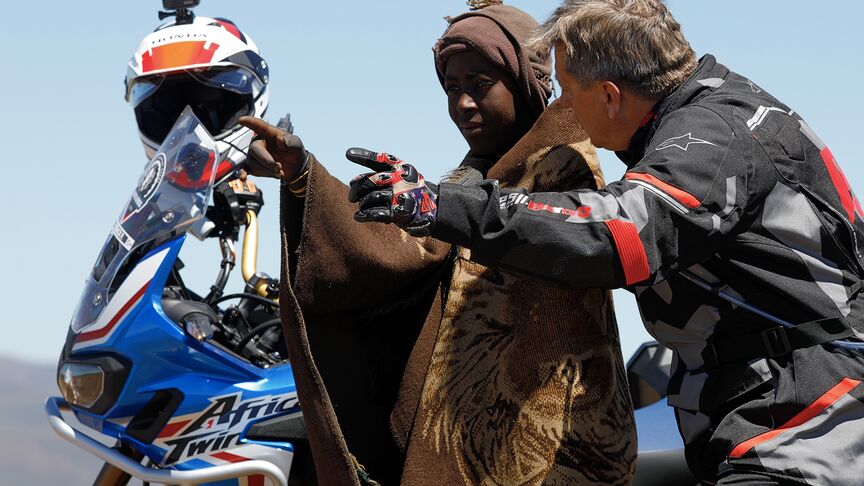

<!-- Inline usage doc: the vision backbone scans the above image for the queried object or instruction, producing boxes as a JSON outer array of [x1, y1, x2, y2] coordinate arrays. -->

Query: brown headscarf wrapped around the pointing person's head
[[433, 2, 552, 115]]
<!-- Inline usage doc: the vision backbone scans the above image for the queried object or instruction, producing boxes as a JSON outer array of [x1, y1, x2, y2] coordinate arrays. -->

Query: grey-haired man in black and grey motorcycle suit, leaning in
[[352, 0, 864, 484]]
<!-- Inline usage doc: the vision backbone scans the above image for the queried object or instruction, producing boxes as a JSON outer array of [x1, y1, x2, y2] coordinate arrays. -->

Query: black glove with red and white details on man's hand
[[345, 148, 438, 236]]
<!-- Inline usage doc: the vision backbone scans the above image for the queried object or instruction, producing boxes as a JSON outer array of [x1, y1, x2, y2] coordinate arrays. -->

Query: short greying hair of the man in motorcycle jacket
[[530, 0, 696, 99]]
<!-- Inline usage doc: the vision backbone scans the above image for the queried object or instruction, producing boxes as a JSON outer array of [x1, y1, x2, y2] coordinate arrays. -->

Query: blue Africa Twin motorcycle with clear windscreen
[[45, 107, 314, 486]]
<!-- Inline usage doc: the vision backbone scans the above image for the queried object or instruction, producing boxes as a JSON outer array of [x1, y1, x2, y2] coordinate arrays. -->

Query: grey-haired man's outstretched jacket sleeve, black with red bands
[[355, 108, 751, 288]]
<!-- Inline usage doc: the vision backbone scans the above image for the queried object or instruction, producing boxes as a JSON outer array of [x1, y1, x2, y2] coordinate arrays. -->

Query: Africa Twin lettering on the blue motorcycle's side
[[156, 393, 299, 464]]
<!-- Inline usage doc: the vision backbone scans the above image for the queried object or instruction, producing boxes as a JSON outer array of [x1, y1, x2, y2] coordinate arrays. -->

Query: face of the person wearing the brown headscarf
[[444, 51, 534, 157]]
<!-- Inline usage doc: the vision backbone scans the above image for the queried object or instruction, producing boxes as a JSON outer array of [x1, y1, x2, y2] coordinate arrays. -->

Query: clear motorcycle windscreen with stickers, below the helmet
[[71, 107, 219, 333]]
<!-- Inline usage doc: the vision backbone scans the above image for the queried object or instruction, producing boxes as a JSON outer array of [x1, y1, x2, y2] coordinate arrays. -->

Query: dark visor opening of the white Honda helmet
[[135, 75, 255, 144]]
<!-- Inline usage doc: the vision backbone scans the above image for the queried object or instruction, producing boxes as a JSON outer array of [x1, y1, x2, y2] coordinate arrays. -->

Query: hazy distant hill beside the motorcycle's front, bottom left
[[0, 357, 102, 486]]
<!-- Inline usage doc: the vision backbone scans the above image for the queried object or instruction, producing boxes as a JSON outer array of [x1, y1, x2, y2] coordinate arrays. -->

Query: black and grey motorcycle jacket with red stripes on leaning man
[[433, 55, 864, 480]]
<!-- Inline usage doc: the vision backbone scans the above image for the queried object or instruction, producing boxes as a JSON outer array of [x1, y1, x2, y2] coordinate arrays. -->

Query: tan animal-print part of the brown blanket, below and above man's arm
[[403, 101, 636, 485]]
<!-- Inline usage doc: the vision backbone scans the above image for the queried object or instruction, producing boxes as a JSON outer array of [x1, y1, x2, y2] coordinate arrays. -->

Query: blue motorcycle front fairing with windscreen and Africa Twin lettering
[[54, 109, 300, 484]]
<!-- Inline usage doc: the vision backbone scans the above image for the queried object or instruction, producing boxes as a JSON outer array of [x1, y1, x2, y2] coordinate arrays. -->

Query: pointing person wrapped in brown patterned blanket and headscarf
[[241, 2, 635, 484]]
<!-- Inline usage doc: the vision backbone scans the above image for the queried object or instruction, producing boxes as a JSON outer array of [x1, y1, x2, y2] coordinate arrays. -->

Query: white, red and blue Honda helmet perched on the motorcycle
[[126, 17, 270, 178]]
